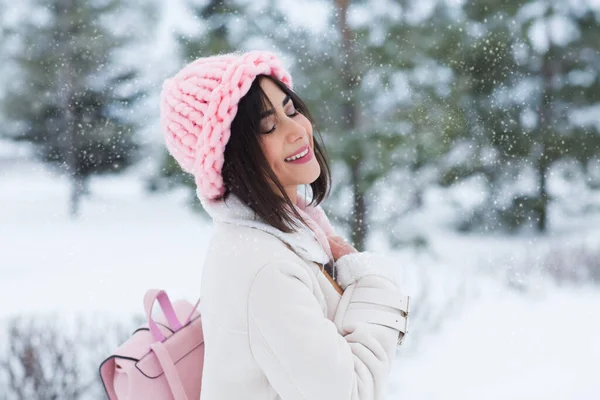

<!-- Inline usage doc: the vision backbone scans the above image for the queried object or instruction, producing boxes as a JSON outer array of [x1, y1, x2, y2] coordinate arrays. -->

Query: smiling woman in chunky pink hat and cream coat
[[161, 51, 408, 400]]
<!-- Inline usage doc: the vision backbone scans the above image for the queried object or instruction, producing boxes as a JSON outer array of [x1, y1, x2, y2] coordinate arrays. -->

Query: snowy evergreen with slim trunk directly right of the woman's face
[[266, 1, 465, 249]]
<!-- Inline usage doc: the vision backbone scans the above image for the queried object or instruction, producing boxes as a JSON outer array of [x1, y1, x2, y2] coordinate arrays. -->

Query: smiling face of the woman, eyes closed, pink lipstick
[[260, 78, 321, 203]]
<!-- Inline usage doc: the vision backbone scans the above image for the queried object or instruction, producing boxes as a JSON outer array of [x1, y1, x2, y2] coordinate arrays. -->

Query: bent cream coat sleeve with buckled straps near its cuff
[[248, 260, 405, 400]]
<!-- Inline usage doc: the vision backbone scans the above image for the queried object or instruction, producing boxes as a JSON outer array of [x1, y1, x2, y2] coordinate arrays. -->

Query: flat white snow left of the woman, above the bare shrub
[[0, 159, 210, 317]]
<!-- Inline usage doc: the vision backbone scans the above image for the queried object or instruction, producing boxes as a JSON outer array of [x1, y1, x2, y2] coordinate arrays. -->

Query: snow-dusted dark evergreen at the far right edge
[[442, 1, 600, 232]]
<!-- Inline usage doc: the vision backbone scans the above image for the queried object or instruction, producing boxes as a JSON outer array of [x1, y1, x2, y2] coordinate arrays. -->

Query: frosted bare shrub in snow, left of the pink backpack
[[0, 315, 139, 400]]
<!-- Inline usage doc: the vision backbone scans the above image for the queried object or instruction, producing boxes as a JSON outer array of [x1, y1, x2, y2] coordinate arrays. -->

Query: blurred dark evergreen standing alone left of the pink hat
[[3, 0, 144, 215]]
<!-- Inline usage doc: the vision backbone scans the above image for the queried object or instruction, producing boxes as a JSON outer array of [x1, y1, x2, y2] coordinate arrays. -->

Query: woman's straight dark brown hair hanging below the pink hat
[[222, 75, 331, 233]]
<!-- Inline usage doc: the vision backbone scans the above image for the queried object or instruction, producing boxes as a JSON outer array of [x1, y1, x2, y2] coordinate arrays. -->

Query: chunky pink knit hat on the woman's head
[[160, 51, 292, 200]]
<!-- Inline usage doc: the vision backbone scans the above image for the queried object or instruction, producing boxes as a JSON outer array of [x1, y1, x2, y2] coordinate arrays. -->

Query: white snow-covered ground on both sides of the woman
[[0, 154, 600, 400]]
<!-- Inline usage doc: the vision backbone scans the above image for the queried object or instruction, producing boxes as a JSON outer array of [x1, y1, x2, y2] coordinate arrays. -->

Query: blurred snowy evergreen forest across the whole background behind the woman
[[0, 0, 600, 399]]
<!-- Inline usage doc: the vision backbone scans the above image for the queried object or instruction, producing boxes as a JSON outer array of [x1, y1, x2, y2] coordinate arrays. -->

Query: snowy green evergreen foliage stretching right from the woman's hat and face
[[151, 0, 600, 240]]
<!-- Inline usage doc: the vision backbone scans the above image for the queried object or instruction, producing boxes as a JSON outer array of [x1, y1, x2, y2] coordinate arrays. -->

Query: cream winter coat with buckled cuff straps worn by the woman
[[200, 195, 408, 400]]
